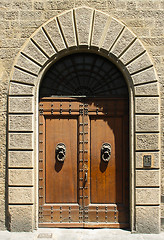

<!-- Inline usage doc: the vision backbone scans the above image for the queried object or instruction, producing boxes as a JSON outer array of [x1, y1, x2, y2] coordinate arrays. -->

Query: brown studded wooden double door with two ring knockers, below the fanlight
[[39, 98, 129, 228]]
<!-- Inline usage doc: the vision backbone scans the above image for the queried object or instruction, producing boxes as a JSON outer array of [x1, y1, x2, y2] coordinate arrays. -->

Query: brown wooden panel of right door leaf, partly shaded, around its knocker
[[90, 116, 122, 204]]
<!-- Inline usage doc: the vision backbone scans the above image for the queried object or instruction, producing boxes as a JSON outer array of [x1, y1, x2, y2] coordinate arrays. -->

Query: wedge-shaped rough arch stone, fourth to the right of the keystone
[[120, 40, 145, 65]]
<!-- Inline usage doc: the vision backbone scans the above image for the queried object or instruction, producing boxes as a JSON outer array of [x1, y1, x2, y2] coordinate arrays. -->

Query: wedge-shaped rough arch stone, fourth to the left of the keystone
[[22, 41, 48, 65]]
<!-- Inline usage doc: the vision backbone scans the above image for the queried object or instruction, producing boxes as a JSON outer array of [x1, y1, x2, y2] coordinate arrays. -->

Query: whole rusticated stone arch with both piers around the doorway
[[8, 7, 160, 233]]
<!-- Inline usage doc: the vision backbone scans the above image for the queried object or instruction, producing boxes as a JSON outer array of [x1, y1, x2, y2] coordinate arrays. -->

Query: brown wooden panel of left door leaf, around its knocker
[[45, 116, 78, 203]]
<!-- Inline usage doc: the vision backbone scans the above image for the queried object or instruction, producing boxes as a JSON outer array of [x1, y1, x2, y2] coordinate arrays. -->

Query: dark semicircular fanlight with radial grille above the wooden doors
[[40, 53, 128, 97]]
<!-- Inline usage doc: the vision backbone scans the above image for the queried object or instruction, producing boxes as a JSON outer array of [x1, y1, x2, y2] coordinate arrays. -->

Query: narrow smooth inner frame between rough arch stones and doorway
[[34, 51, 136, 232]]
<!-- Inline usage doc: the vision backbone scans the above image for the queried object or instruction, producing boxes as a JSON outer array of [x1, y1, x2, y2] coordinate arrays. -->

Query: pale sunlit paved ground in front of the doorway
[[0, 228, 164, 240]]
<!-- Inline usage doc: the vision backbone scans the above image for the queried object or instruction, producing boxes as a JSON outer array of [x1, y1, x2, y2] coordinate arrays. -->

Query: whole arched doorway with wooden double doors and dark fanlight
[[39, 53, 129, 228]]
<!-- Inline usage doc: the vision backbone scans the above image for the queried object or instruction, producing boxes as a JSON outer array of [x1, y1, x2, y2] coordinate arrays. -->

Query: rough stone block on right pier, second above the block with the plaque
[[135, 115, 159, 132]]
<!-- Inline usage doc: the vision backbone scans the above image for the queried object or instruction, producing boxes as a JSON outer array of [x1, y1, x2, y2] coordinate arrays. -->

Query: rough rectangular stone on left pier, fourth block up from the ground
[[8, 151, 34, 167]]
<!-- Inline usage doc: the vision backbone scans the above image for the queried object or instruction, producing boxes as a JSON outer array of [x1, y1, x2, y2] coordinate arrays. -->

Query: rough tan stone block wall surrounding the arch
[[0, 0, 164, 232]]
